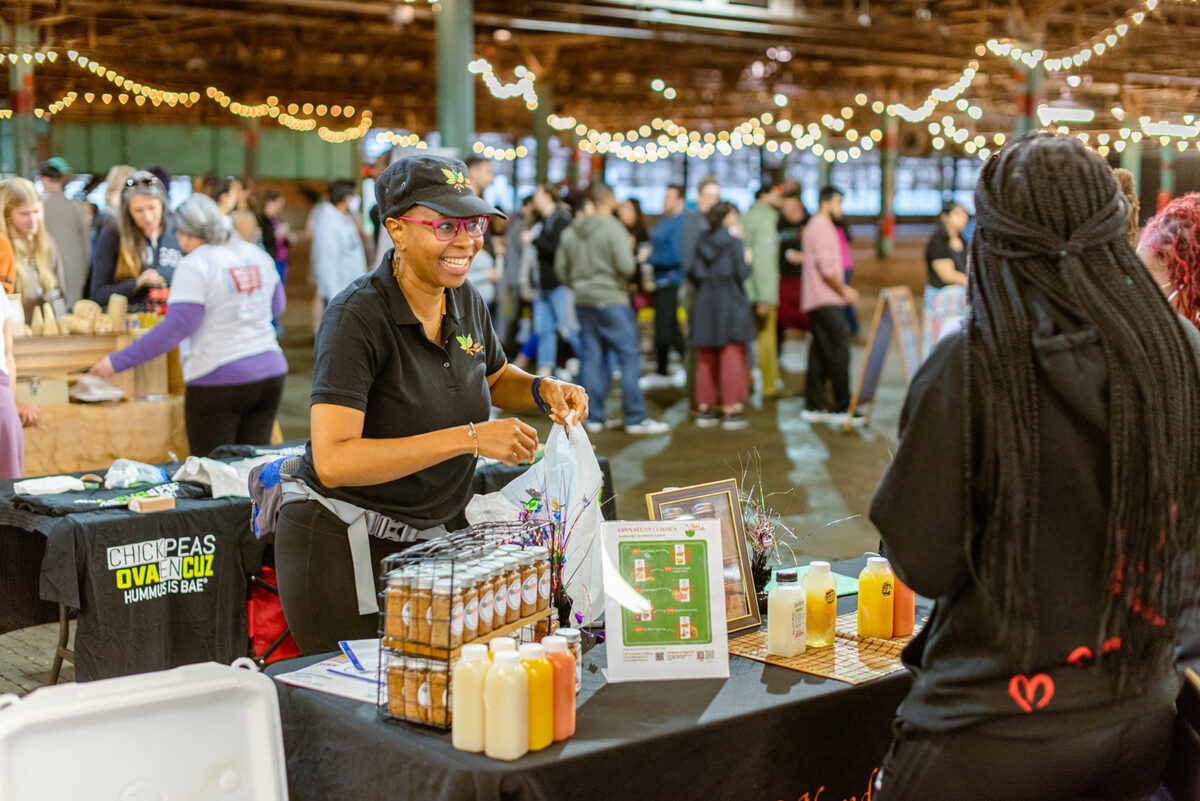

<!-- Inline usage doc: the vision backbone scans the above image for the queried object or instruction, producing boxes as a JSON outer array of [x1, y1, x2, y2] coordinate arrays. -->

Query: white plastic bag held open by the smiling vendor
[[467, 424, 604, 626]]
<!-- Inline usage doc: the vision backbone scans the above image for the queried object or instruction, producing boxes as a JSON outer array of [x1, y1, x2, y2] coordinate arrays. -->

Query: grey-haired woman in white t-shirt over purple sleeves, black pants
[[91, 194, 288, 456]]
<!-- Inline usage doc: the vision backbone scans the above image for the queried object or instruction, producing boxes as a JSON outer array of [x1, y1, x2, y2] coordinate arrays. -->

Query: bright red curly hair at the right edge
[[1141, 192, 1200, 327]]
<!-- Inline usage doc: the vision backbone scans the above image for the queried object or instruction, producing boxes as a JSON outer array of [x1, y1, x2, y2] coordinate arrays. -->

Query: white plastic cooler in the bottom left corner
[[0, 660, 288, 801]]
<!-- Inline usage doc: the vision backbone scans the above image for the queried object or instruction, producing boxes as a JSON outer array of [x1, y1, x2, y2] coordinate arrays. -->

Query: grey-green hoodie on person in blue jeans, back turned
[[554, 213, 637, 306]]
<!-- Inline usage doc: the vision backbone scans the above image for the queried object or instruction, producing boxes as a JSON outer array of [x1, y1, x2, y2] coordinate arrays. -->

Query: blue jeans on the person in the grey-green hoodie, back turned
[[575, 303, 646, 426]]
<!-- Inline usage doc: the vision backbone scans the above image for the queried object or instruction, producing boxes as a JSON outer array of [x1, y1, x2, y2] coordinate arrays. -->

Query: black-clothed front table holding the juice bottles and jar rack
[[268, 560, 928, 801]]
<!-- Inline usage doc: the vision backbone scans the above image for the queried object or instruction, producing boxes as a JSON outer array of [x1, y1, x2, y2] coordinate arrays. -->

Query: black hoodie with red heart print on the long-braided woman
[[871, 290, 1200, 737]]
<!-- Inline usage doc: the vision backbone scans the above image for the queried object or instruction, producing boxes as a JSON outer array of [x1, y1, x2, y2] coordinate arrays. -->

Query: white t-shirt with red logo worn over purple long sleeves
[[167, 237, 282, 381]]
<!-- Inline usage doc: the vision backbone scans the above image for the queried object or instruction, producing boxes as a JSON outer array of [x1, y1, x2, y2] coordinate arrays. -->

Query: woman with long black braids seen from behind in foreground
[[871, 133, 1200, 801]]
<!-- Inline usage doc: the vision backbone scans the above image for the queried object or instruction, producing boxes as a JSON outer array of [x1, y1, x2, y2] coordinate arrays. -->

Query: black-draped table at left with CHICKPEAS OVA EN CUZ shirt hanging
[[0, 453, 616, 681]]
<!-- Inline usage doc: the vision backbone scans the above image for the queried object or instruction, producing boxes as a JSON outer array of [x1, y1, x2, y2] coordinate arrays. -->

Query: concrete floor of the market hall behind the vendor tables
[[0, 231, 928, 694]]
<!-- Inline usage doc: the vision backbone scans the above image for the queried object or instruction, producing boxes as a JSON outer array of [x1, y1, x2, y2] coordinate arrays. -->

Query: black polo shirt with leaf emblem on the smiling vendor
[[298, 251, 505, 529]]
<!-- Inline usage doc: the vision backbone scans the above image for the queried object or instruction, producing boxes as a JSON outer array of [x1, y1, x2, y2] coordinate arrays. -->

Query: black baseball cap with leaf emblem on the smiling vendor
[[376, 156, 508, 219]]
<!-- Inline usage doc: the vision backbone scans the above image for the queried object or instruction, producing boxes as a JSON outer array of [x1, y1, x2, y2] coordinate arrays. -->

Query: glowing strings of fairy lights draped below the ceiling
[[0, 0, 1200, 163]]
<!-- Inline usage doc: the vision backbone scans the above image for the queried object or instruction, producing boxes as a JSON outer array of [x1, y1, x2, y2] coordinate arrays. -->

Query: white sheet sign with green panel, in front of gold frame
[[601, 520, 730, 681]]
